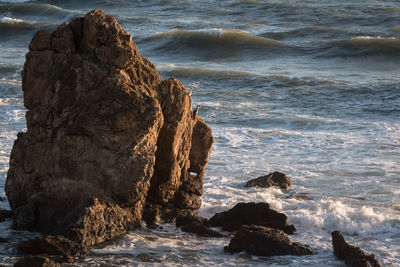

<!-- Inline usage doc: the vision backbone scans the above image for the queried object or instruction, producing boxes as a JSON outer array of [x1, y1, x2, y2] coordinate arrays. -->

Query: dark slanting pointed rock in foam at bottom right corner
[[332, 231, 381, 267]]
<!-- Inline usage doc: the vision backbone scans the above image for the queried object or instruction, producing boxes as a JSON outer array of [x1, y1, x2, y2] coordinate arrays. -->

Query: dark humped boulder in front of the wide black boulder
[[225, 225, 315, 256]]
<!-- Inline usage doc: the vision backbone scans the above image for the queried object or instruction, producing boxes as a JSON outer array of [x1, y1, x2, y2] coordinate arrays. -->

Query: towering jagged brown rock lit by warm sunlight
[[5, 9, 213, 245]]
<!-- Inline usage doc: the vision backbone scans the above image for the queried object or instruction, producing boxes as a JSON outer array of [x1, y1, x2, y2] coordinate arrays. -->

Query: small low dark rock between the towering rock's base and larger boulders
[[176, 216, 223, 237]]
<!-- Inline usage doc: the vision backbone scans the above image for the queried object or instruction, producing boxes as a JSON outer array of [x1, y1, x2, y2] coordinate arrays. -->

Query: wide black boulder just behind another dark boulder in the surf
[[208, 202, 296, 234]]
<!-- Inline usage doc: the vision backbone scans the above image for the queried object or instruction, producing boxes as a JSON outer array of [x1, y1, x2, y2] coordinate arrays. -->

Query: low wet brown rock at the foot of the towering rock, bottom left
[[17, 236, 87, 262]]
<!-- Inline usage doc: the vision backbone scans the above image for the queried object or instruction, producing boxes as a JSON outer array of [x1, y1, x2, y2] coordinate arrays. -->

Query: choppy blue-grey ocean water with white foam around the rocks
[[0, 0, 400, 266]]
